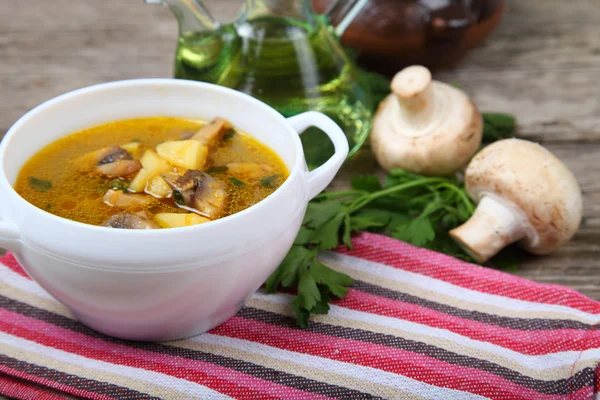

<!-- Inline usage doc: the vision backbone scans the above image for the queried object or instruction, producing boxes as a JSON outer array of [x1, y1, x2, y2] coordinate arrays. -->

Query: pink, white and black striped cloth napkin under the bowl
[[0, 234, 600, 400]]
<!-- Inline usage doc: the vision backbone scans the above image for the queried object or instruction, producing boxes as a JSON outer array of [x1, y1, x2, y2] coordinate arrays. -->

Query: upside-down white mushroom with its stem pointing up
[[371, 66, 483, 176]]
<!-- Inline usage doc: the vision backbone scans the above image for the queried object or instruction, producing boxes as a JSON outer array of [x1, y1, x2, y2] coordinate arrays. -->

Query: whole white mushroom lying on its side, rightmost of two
[[450, 139, 583, 262]]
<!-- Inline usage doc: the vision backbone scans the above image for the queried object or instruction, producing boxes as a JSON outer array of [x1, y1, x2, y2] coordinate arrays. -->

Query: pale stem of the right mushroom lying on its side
[[450, 195, 532, 263]]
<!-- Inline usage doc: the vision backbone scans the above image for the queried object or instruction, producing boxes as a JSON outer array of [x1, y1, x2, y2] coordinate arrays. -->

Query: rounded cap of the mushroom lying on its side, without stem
[[465, 139, 583, 254]]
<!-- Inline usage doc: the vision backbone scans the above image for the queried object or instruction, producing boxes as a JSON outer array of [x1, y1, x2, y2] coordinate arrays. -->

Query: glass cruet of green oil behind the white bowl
[[145, 0, 375, 168]]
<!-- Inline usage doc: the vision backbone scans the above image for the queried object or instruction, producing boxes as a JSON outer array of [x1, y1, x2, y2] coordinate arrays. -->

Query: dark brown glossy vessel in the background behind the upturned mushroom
[[313, 0, 505, 75]]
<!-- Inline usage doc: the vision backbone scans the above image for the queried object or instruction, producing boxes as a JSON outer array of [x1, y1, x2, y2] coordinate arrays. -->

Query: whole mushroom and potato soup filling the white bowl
[[15, 117, 289, 229]]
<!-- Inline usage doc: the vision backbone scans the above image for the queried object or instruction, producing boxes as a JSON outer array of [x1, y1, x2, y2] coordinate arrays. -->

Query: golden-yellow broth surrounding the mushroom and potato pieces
[[15, 117, 289, 225]]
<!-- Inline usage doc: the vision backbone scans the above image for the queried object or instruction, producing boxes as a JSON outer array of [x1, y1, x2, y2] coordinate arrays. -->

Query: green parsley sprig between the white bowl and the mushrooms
[[265, 170, 506, 327]]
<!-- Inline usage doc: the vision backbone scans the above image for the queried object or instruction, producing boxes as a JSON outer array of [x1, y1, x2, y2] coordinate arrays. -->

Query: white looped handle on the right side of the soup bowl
[[288, 111, 349, 199]]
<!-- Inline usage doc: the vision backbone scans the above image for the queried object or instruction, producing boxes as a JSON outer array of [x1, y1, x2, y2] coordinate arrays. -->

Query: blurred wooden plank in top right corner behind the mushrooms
[[438, 0, 600, 141]]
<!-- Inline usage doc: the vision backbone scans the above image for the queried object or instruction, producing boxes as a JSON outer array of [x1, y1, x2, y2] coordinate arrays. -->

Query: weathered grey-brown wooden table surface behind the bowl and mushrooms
[[0, 0, 600, 300]]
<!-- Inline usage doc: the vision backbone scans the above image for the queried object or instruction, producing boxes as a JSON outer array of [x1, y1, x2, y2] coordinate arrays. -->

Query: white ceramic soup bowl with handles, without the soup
[[0, 79, 348, 340]]
